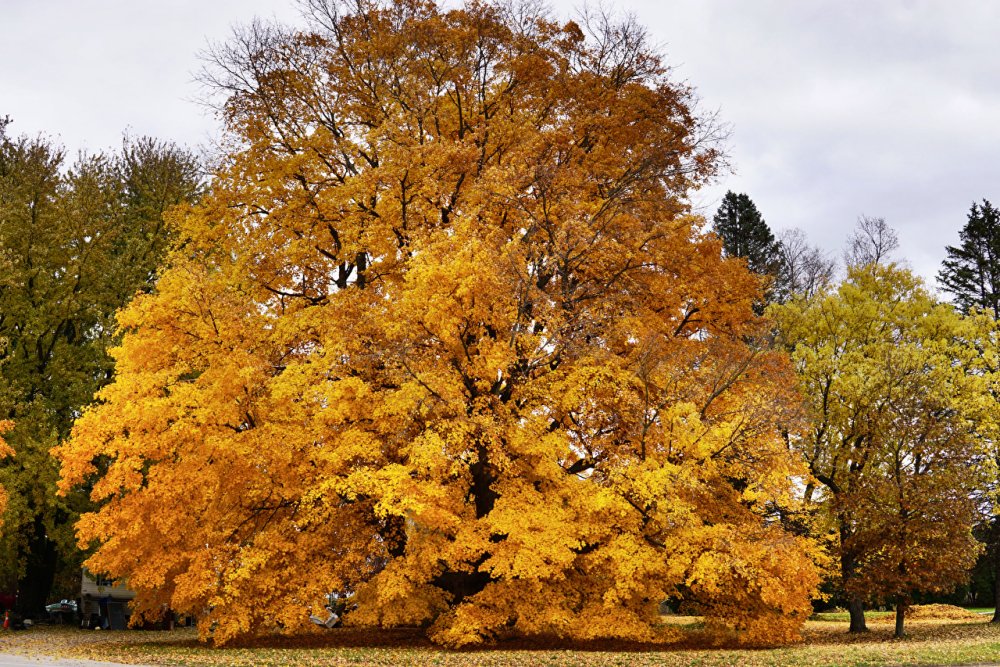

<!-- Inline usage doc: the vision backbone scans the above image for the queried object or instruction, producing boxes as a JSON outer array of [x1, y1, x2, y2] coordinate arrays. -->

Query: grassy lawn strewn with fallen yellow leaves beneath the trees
[[0, 614, 1000, 667]]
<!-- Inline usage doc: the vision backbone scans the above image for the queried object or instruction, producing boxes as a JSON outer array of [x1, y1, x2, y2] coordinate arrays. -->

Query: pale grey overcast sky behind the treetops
[[0, 0, 1000, 288]]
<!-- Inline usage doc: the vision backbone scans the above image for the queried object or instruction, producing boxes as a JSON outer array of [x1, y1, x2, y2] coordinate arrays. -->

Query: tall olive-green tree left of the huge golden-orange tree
[[0, 125, 198, 612]]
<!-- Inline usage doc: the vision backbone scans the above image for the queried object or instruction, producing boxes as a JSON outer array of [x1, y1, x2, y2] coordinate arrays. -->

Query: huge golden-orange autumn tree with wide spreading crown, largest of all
[[58, 0, 817, 645]]
